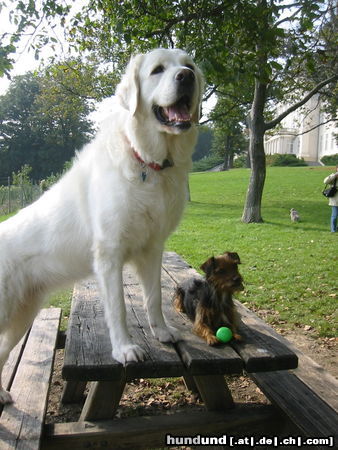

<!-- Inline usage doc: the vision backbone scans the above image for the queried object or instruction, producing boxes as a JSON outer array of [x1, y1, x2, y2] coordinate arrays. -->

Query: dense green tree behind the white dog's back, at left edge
[[0, 62, 92, 179]]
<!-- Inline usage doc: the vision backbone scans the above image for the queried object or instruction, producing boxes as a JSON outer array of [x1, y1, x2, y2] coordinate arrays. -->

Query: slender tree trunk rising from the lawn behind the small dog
[[242, 79, 266, 223]]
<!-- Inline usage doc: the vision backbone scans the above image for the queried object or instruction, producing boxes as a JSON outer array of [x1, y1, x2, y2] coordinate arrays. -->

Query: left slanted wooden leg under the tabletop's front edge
[[79, 376, 126, 421]]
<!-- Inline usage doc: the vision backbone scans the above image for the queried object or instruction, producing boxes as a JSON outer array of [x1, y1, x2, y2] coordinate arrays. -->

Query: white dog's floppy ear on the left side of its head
[[115, 54, 144, 115]]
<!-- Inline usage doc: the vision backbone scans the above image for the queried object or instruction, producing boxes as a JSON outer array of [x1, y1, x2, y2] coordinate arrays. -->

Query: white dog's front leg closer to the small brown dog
[[136, 249, 181, 342]]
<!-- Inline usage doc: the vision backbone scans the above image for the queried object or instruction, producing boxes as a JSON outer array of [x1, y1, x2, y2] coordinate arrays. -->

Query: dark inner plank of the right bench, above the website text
[[250, 371, 338, 448]]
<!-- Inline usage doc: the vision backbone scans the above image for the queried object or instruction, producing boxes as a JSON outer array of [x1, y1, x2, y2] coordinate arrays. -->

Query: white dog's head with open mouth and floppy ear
[[116, 49, 203, 134]]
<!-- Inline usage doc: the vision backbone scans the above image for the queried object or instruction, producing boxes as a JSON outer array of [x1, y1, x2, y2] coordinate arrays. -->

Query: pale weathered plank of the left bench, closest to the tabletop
[[0, 308, 61, 450]]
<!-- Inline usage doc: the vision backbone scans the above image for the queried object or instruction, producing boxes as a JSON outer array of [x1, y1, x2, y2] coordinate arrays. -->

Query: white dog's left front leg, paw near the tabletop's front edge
[[95, 246, 145, 364]]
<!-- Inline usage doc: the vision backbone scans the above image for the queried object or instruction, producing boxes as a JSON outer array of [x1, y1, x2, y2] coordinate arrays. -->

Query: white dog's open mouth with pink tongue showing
[[153, 96, 191, 129]]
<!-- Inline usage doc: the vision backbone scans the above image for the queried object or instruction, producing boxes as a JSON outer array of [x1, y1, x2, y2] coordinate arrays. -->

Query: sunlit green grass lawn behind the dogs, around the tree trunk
[[0, 167, 338, 336]]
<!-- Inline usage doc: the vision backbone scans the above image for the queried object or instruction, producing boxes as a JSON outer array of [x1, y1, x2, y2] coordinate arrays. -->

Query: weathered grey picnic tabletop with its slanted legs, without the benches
[[62, 252, 298, 421]]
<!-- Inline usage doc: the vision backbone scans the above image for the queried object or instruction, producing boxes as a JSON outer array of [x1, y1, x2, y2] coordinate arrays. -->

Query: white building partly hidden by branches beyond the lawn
[[265, 96, 338, 161]]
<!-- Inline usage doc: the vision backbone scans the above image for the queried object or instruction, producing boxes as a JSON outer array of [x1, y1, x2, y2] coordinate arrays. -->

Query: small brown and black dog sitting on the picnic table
[[174, 252, 244, 345]]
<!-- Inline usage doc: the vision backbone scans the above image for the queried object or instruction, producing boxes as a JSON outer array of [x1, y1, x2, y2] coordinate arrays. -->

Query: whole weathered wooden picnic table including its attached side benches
[[0, 253, 338, 450]]
